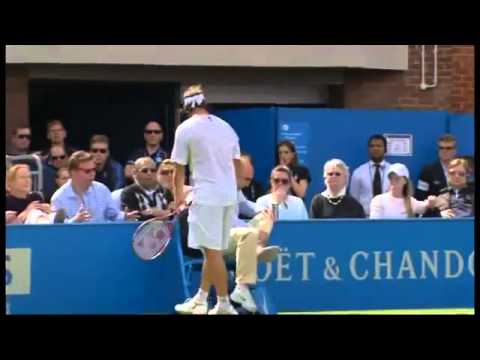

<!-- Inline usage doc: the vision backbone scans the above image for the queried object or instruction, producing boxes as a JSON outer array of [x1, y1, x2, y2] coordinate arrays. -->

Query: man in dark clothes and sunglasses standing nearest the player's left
[[125, 120, 169, 178]]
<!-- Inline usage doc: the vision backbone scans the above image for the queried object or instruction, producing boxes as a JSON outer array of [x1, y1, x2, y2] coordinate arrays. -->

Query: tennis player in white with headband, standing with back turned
[[171, 85, 241, 315]]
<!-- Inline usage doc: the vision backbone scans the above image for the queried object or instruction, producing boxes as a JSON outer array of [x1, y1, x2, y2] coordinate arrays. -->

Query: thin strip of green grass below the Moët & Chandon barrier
[[279, 309, 475, 315]]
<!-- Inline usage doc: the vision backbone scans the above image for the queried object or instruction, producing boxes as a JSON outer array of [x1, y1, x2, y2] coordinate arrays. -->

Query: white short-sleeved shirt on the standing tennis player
[[172, 114, 240, 206]]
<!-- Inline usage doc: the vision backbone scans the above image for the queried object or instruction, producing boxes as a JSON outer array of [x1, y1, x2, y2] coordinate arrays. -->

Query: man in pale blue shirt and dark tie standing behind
[[350, 134, 390, 216]]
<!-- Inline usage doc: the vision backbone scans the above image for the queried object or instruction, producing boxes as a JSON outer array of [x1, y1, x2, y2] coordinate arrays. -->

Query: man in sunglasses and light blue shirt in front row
[[52, 151, 138, 223]]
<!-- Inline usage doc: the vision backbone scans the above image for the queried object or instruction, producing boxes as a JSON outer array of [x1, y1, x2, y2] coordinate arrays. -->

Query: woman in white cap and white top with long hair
[[370, 163, 436, 219]]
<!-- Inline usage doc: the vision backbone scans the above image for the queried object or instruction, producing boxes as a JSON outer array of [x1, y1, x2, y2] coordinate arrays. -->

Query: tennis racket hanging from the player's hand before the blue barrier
[[132, 218, 175, 261]]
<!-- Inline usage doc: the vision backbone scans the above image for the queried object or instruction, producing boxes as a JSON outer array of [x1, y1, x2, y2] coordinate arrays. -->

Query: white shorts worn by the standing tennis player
[[188, 203, 235, 251]]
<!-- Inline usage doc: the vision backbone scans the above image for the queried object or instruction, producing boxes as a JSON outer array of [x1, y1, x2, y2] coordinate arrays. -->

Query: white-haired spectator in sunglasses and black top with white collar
[[310, 159, 365, 219]]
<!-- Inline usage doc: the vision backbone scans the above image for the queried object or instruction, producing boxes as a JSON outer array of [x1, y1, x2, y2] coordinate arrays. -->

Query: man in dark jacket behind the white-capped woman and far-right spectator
[[415, 134, 457, 217]]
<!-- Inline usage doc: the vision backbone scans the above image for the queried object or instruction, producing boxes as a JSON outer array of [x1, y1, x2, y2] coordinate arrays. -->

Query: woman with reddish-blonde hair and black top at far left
[[6, 164, 64, 224]]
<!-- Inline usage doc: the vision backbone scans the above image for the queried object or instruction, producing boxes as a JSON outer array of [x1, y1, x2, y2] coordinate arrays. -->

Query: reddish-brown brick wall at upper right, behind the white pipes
[[345, 45, 474, 112]]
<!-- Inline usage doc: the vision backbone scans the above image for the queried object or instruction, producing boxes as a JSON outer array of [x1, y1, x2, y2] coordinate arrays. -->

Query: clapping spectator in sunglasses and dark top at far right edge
[[437, 159, 475, 219]]
